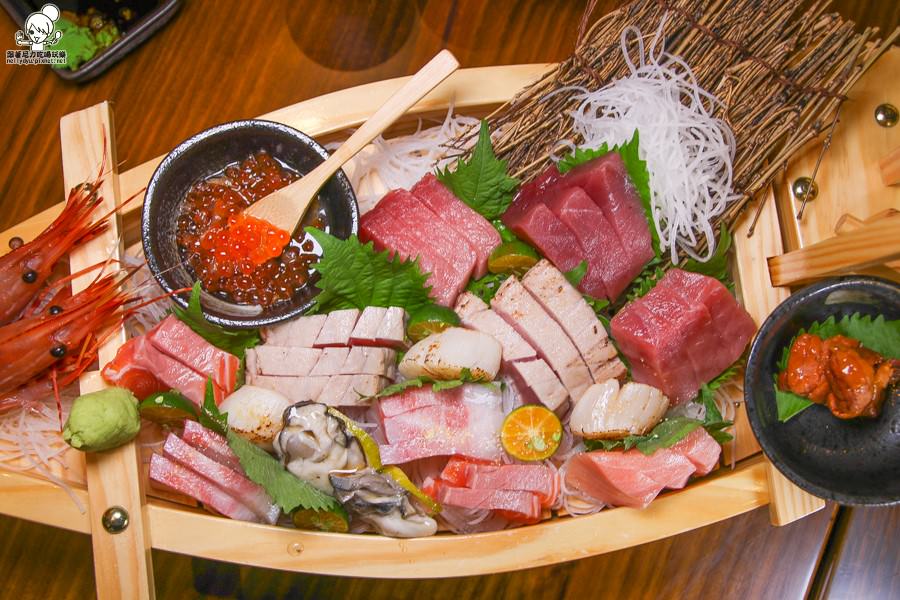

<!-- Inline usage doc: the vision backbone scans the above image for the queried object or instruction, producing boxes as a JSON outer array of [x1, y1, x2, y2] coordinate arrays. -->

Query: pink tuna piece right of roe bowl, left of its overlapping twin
[[359, 190, 475, 306]]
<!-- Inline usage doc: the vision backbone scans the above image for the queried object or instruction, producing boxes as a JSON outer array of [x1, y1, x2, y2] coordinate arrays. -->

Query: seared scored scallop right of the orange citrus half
[[569, 379, 669, 439]]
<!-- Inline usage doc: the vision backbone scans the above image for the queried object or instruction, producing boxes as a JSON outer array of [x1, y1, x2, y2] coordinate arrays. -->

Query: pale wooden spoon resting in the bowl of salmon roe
[[244, 50, 459, 232]]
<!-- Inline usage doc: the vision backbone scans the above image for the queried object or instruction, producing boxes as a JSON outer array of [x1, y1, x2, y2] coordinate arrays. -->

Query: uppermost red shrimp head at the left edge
[[0, 172, 107, 325]]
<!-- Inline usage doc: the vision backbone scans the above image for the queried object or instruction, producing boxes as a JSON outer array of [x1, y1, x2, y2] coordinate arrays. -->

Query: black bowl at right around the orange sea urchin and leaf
[[744, 276, 900, 505]]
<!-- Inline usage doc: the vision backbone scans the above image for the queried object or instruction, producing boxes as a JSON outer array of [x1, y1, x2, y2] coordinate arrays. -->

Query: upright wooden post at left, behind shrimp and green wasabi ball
[[59, 102, 155, 600]]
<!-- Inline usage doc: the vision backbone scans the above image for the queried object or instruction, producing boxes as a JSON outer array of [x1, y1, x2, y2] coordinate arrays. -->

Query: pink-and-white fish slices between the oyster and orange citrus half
[[381, 384, 503, 464]]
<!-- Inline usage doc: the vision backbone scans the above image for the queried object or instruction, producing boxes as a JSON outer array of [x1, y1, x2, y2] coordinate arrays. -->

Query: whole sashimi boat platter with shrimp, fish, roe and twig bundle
[[0, 0, 896, 585]]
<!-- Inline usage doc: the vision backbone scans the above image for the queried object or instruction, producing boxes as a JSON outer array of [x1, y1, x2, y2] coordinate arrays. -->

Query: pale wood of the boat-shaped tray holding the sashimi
[[0, 52, 897, 597]]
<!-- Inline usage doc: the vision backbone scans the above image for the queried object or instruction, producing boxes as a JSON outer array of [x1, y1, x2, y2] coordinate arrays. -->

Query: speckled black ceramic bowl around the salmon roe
[[141, 120, 359, 328]]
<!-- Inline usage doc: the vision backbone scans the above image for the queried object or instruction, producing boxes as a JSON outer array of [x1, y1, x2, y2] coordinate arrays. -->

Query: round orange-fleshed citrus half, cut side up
[[500, 404, 563, 461]]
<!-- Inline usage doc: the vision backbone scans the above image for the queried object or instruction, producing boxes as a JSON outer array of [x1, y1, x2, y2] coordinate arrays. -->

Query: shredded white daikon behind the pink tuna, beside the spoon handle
[[327, 106, 478, 213]]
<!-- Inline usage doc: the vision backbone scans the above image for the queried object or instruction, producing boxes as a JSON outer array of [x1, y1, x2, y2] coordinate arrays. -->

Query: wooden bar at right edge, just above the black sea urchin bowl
[[768, 216, 900, 285]]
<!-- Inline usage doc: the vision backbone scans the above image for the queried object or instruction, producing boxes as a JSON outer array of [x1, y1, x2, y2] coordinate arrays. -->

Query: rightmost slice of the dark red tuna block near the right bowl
[[659, 269, 756, 382]]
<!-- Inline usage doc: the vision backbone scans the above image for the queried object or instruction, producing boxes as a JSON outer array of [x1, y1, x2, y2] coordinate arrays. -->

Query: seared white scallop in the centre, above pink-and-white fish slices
[[399, 327, 502, 381]]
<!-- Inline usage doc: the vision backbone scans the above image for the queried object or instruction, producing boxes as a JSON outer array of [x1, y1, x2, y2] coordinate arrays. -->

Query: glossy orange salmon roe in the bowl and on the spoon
[[176, 152, 323, 306]]
